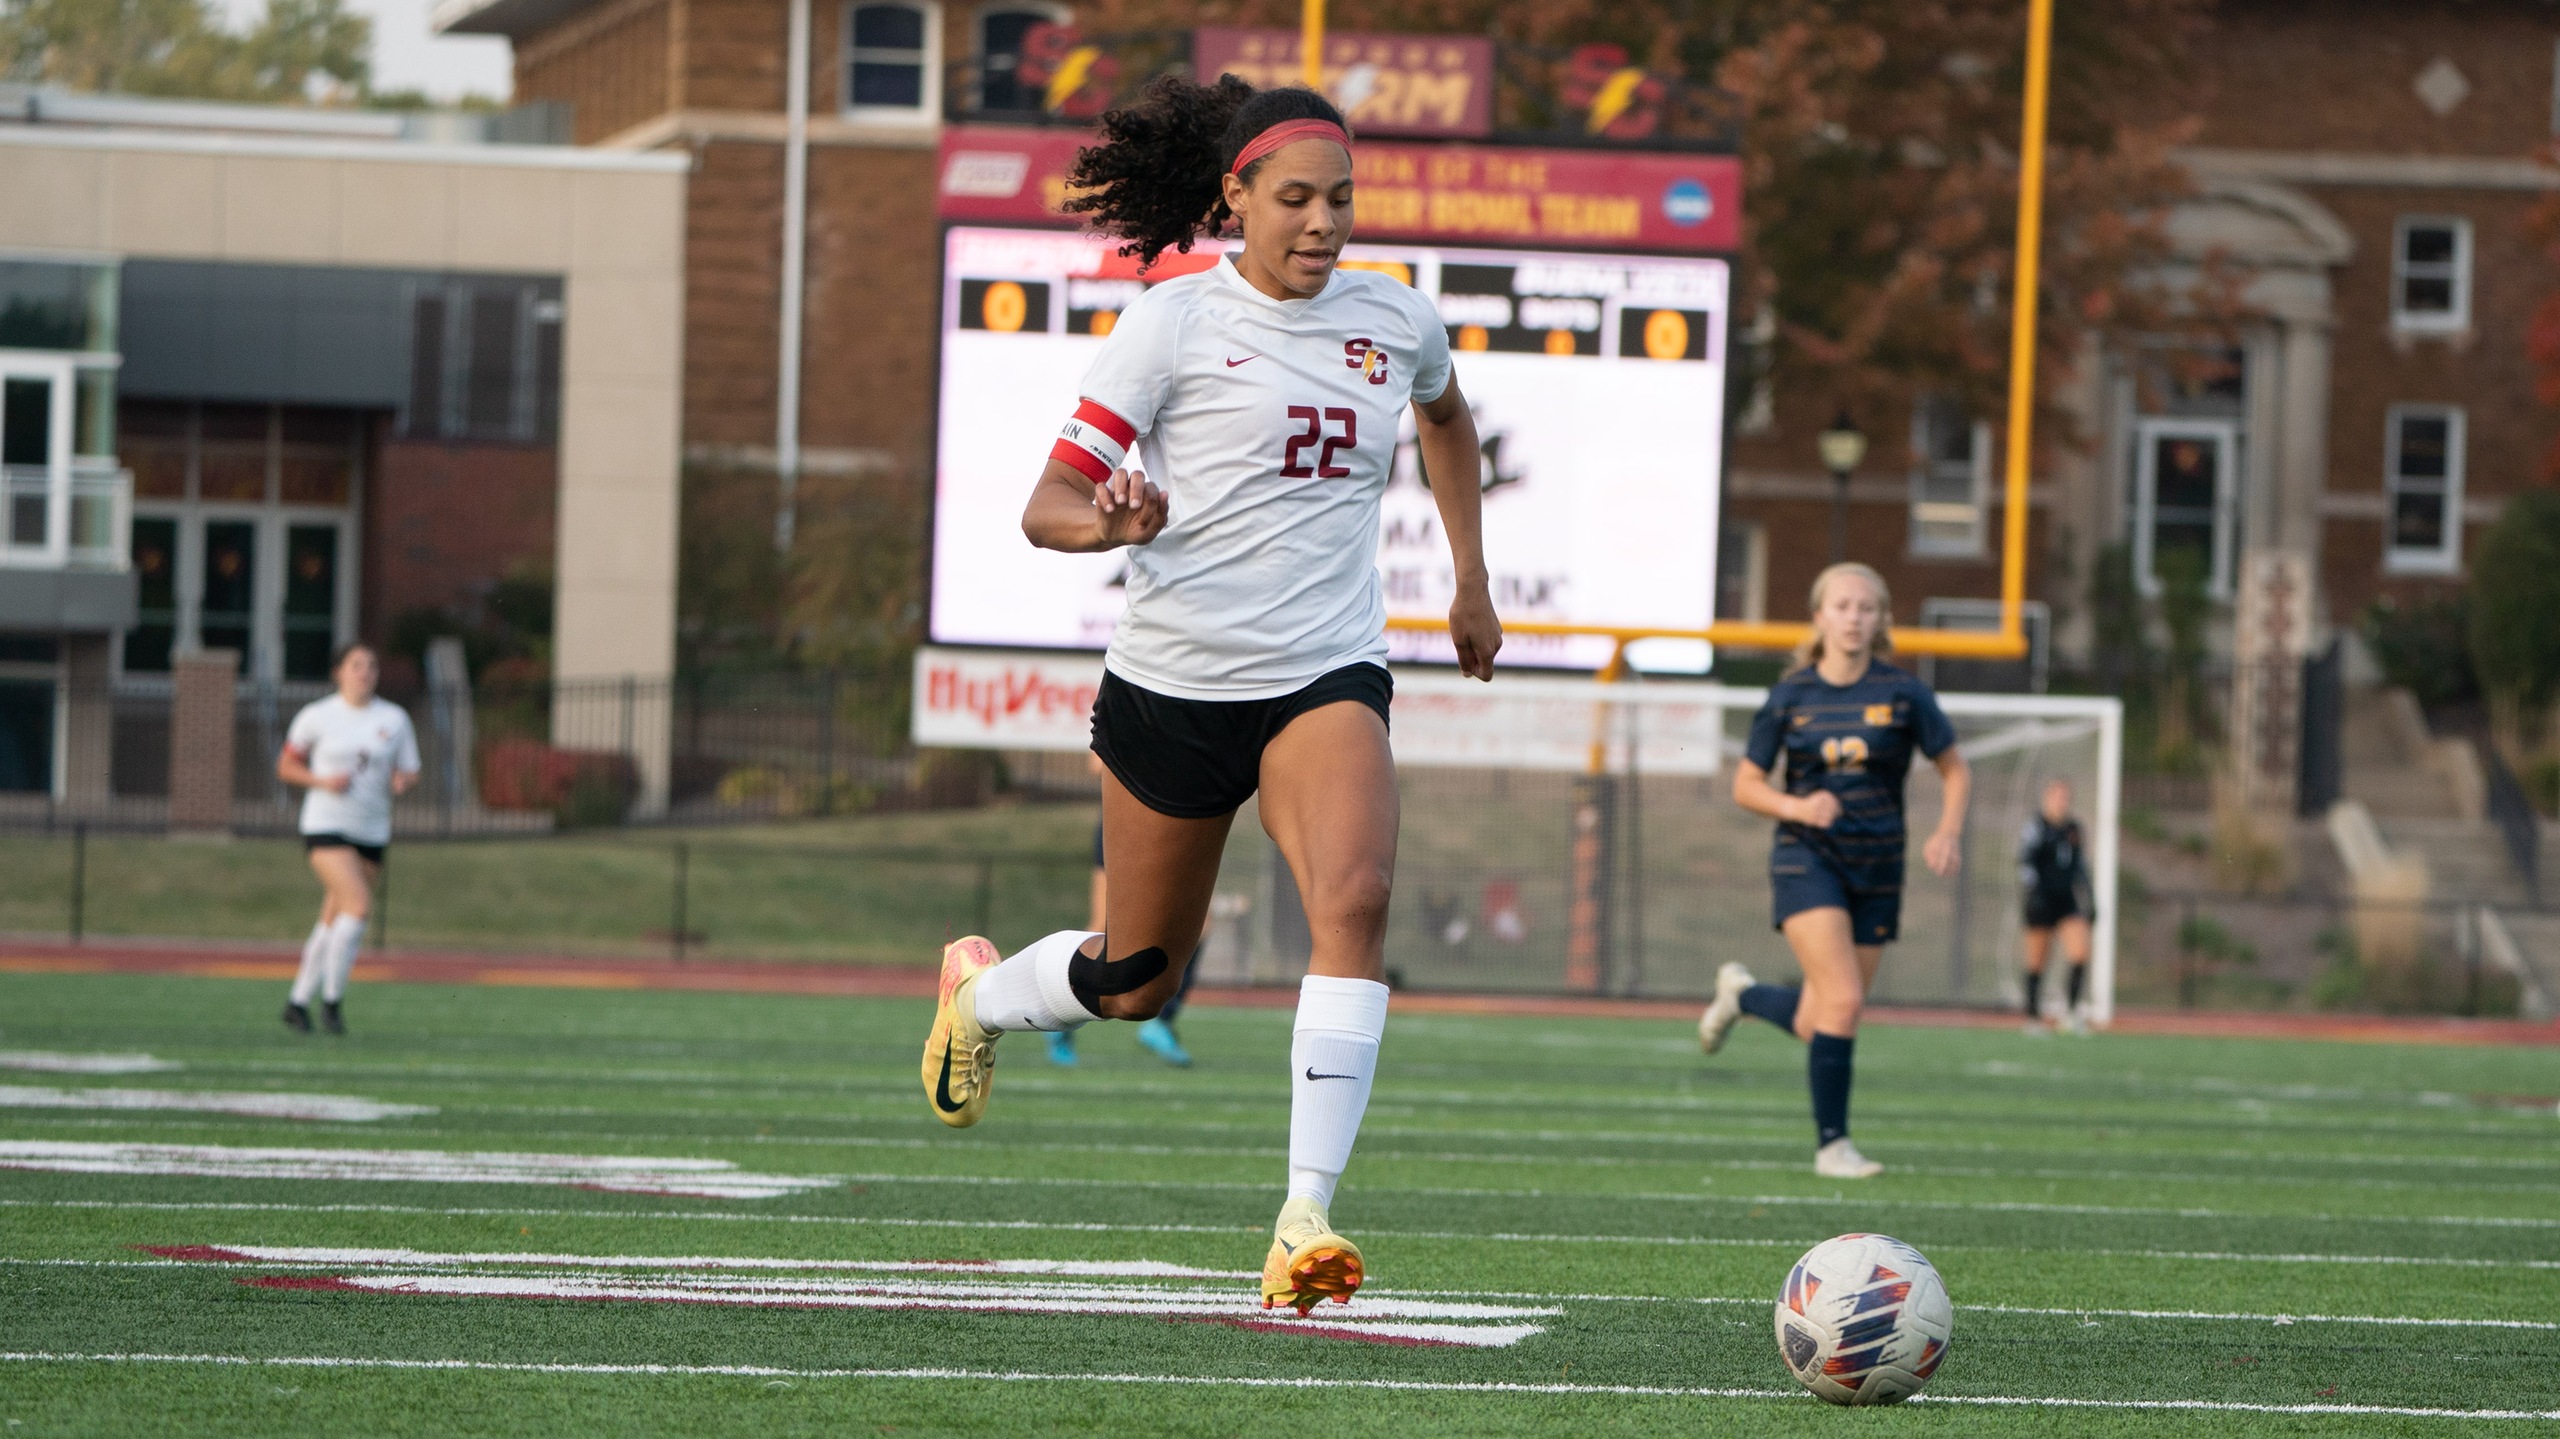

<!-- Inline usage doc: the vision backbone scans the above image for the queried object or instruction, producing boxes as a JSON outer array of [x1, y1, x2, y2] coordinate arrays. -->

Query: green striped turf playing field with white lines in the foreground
[[0, 976, 2560, 1439]]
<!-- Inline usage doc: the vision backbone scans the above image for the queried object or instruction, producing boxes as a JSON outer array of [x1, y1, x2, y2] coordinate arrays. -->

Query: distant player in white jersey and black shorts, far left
[[276, 645, 420, 1034]]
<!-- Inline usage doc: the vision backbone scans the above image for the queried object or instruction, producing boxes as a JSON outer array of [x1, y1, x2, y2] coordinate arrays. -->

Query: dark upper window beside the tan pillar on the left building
[[399, 279, 561, 446]]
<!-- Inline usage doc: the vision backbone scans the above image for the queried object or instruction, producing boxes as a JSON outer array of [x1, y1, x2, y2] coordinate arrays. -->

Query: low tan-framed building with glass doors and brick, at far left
[[0, 87, 686, 814]]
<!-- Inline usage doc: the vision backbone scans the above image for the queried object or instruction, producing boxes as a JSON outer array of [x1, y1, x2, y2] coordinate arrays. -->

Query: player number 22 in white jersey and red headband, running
[[924, 77, 1503, 1314]]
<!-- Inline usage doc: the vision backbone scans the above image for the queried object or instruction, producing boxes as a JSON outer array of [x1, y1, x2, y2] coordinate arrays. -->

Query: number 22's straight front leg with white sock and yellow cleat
[[1262, 702, 1398, 1314]]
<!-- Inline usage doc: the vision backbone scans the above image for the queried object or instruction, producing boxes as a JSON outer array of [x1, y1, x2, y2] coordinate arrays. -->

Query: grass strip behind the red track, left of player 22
[[0, 804, 1096, 965]]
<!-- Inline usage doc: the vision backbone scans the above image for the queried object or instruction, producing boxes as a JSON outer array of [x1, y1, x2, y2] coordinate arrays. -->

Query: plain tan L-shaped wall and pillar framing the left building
[[0, 125, 689, 796]]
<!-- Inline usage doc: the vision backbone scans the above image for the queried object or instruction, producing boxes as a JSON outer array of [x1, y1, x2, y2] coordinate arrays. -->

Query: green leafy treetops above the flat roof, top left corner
[[0, 0, 374, 102]]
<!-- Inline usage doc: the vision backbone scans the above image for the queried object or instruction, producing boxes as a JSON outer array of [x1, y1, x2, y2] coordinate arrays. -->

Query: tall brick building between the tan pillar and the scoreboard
[[438, 0, 962, 486]]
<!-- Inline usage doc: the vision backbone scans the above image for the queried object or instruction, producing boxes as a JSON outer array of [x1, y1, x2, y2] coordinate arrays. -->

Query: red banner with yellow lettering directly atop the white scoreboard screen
[[937, 125, 1743, 253]]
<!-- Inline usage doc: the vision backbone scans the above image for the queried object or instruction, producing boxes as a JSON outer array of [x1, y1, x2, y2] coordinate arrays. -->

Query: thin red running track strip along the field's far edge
[[0, 940, 2560, 1047]]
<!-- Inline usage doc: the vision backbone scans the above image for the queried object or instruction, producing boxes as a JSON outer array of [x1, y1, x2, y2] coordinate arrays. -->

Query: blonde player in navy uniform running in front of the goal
[[1697, 563, 1974, 1180]]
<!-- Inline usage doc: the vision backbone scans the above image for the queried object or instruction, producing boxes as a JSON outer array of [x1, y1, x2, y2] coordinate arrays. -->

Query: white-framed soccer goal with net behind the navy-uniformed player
[[1203, 671, 2122, 1022]]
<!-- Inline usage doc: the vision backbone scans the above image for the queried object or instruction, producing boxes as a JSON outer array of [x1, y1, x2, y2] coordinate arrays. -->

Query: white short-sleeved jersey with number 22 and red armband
[[1052, 259, 1449, 699]]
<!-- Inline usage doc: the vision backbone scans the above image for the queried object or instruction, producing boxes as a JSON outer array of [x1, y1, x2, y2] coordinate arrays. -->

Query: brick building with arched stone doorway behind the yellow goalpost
[[1728, 0, 2560, 658]]
